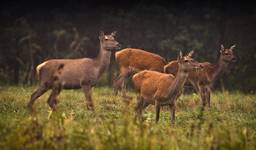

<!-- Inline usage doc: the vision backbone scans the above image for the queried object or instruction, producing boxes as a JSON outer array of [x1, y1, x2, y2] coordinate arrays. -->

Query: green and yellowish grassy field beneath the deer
[[0, 87, 256, 150]]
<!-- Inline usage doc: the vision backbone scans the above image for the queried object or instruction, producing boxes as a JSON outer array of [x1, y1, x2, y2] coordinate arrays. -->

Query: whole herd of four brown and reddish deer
[[27, 32, 236, 124]]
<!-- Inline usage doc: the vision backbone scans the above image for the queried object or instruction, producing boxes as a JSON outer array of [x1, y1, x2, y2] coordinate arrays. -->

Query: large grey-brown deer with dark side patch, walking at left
[[27, 31, 120, 111]]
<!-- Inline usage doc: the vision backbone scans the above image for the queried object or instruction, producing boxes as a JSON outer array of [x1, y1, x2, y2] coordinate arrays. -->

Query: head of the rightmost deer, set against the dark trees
[[220, 45, 236, 64]]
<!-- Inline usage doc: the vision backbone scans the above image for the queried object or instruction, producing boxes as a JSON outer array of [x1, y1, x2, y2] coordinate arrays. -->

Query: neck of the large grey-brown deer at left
[[95, 42, 111, 75]]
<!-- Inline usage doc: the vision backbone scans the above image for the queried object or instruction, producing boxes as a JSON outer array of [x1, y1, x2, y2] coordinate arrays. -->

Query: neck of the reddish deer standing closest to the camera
[[168, 69, 188, 103]]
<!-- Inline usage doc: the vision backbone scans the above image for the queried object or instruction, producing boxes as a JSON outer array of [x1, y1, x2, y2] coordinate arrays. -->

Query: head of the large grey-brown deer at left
[[99, 31, 120, 51]]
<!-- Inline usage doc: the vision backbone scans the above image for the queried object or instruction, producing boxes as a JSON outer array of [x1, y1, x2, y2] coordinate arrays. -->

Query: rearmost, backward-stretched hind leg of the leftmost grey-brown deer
[[27, 83, 49, 111]]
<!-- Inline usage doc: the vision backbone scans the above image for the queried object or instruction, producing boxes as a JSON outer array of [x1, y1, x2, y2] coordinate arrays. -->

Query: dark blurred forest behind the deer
[[0, 0, 256, 92]]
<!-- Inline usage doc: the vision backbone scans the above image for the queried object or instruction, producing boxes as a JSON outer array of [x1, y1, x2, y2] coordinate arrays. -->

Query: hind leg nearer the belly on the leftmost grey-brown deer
[[47, 84, 61, 111]]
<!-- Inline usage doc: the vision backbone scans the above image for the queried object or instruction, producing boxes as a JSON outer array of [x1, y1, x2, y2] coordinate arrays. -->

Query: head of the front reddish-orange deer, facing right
[[177, 51, 203, 72]]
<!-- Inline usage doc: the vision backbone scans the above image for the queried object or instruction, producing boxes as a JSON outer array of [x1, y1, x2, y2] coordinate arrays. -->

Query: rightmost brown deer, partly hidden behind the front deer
[[164, 45, 236, 108]]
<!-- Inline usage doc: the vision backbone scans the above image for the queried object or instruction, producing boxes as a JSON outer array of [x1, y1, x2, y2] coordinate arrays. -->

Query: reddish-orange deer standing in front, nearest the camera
[[132, 51, 202, 124]]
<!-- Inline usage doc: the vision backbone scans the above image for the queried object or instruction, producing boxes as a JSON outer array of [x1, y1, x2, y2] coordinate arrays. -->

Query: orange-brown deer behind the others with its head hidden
[[113, 48, 167, 97]]
